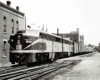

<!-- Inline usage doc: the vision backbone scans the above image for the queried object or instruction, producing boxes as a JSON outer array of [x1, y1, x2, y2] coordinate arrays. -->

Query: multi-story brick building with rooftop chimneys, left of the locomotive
[[0, 1, 25, 65]]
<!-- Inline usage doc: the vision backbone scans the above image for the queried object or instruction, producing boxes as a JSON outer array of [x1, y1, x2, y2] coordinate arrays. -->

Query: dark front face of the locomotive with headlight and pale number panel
[[9, 34, 23, 64]]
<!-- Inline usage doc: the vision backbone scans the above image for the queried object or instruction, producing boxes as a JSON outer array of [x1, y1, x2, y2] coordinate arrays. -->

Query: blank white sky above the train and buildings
[[0, 0, 100, 45]]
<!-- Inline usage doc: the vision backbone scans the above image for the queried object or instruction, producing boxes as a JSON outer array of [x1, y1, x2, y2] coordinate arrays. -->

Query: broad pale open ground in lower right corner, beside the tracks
[[52, 53, 100, 80]]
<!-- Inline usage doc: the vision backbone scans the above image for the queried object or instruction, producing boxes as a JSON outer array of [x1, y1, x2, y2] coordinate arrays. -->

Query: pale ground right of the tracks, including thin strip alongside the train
[[40, 53, 100, 80]]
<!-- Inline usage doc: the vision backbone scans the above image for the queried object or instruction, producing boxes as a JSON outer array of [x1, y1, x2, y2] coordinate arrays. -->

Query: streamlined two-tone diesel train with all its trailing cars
[[9, 29, 93, 64]]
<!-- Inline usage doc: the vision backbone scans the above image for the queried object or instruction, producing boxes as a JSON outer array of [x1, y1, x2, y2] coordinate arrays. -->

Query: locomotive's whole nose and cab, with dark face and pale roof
[[9, 30, 39, 64]]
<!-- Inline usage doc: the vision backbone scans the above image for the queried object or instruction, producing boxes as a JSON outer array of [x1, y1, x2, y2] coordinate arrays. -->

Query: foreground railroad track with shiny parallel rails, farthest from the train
[[0, 61, 76, 80]]
